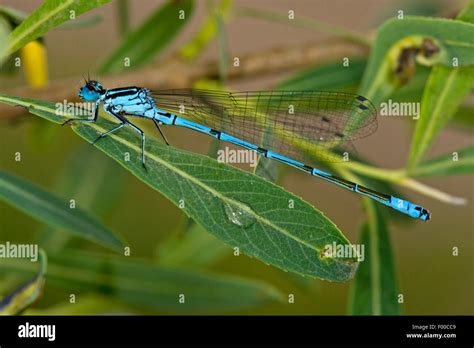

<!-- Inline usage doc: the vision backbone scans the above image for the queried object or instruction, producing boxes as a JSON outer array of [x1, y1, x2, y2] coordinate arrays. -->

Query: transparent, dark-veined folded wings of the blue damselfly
[[150, 89, 377, 162]]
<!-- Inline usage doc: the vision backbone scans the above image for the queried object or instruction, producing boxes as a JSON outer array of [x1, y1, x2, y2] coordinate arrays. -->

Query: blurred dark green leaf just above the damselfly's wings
[[277, 58, 367, 91]]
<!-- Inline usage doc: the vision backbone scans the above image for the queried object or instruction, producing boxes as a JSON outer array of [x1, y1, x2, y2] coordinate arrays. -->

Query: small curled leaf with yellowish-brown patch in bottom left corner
[[0, 249, 48, 315]]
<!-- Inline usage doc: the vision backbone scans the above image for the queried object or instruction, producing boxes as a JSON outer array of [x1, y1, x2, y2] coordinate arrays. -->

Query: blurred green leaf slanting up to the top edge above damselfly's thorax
[[99, 0, 194, 74]]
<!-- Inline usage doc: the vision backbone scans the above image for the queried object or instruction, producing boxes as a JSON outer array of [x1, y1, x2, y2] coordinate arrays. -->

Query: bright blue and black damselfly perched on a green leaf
[[65, 80, 430, 221]]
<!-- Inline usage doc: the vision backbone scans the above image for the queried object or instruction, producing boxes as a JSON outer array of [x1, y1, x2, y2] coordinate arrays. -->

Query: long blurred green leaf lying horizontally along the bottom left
[[1, 250, 282, 313]]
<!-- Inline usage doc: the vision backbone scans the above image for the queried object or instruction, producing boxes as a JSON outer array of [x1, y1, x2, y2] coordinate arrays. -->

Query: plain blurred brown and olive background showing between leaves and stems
[[0, 0, 474, 315]]
